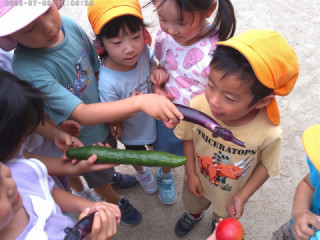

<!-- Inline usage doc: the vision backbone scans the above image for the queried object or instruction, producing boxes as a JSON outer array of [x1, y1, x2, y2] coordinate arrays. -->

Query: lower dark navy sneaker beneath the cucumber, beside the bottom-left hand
[[118, 197, 142, 226]]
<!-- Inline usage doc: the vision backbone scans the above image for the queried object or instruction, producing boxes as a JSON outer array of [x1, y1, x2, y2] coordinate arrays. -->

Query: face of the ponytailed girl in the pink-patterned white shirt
[[154, 0, 207, 46]]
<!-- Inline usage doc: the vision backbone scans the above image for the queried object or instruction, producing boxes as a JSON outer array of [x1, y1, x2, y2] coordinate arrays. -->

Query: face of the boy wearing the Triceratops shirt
[[205, 69, 257, 126]]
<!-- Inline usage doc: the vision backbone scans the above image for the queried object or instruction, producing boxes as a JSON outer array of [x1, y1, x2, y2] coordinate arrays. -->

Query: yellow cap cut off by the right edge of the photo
[[302, 124, 320, 172]]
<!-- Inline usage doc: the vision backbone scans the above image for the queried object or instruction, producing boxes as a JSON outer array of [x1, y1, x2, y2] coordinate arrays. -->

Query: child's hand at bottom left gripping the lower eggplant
[[80, 202, 121, 240]]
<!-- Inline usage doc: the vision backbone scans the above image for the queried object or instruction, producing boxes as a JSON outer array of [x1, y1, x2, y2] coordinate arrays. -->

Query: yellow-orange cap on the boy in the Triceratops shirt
[[216, 29, 299, 125]]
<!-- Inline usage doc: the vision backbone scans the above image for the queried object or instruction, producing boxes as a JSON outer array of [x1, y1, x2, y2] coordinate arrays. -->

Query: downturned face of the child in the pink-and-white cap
[[10, 4, 64, 48]]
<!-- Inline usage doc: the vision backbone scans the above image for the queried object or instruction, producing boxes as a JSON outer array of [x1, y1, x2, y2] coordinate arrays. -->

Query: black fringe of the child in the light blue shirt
[[96, 15, 145, 59]]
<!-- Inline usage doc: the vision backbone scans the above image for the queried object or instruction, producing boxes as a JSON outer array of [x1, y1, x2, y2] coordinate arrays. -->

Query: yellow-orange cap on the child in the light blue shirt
[[88, 0, 143, 35]]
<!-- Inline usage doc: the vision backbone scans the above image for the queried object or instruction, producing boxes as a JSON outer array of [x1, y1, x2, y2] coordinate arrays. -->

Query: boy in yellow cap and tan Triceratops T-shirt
[[174, 29, 299, 237]]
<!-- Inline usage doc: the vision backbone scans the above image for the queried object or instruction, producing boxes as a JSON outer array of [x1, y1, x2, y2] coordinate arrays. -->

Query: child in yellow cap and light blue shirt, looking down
[[88, 0, 168, 194]]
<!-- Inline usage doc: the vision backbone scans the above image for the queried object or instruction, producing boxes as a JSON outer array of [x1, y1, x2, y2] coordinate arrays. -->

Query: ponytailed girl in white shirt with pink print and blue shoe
[[152, 0, 236, 204]]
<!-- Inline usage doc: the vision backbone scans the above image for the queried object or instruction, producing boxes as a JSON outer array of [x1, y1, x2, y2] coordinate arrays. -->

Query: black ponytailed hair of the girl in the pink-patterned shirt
[[147, 0, 236, 41]]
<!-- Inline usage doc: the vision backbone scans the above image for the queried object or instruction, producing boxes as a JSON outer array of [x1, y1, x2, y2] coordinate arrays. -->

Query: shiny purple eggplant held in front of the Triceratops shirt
[[174, 103, 245, 147]]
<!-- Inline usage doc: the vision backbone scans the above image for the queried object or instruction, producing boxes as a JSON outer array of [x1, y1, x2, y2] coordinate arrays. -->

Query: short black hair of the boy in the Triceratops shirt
[[210, 46, 273, 107]]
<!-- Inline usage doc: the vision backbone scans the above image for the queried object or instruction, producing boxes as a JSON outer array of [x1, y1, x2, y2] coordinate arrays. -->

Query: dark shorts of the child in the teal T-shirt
[[82, 135, 117, 188]]
